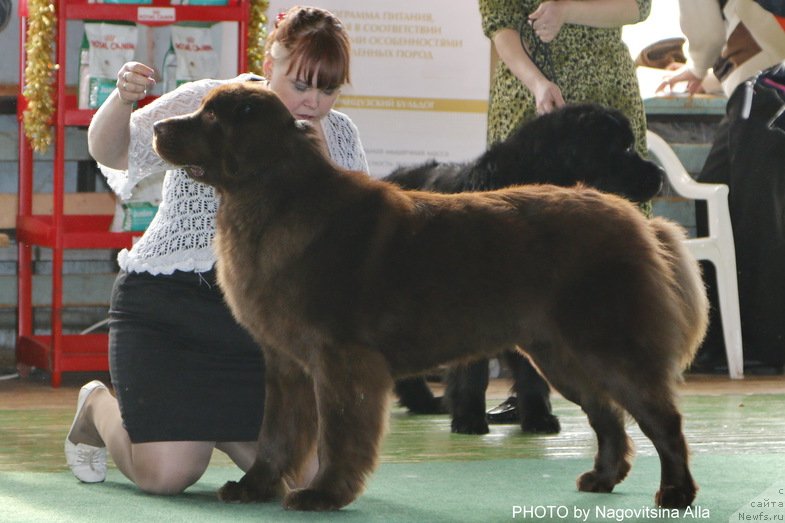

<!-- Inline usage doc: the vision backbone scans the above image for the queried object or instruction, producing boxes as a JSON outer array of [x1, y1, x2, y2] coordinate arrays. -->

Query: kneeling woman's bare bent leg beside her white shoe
[[69, 388, 211, 495]]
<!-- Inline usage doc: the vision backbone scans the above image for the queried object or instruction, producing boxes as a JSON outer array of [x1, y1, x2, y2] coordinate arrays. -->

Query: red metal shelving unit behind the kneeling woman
[[16, 0, 250, 387]]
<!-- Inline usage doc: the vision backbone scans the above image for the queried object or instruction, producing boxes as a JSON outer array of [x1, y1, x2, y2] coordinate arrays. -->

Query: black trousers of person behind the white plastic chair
[[697, 67, 785, 367]]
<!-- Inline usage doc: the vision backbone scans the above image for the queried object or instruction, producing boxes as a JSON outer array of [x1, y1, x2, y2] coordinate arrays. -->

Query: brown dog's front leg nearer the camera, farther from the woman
[[283, 346, 393, 510]]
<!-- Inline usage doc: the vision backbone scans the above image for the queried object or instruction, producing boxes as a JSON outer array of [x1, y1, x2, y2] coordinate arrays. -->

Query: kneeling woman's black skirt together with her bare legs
[[92, 272, 264, 494]]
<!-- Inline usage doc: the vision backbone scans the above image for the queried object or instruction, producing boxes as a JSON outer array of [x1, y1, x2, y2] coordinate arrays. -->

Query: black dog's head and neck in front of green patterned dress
[[474, 104, 663, 202]]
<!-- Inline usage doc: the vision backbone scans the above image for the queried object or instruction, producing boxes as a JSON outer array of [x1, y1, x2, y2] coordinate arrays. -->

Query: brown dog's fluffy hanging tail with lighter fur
[[651, 217, 709, 371]]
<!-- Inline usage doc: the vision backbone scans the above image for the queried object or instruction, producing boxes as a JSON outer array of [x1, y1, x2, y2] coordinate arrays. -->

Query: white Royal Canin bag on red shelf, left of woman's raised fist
[[78, 22, 137, 109]]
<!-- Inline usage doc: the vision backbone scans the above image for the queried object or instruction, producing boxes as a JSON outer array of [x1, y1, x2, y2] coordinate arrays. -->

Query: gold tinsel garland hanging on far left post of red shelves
[[22, 0, 58, 152]]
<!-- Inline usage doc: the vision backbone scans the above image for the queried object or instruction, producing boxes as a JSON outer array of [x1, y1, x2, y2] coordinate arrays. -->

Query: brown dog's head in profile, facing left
[[153, 81, 315, 189]]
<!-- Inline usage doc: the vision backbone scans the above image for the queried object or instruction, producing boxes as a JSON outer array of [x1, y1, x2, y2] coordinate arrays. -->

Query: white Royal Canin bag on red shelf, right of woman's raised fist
[[162, 23, 219, 93]]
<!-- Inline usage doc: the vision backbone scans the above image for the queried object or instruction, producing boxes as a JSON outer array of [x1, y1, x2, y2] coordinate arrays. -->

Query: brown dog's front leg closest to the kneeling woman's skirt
[[218, 350, 317, 503]]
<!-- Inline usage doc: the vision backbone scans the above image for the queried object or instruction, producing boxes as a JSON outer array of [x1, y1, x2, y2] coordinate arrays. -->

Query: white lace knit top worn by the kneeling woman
[[100, 75, 368, 274]]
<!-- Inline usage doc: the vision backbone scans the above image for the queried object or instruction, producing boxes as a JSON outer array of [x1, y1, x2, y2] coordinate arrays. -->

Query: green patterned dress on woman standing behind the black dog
[[480, 0, 651, 156]]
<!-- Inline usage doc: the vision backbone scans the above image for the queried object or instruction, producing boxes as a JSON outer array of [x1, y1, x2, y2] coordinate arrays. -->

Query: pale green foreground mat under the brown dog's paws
[[0, 454, 785, 523]]
